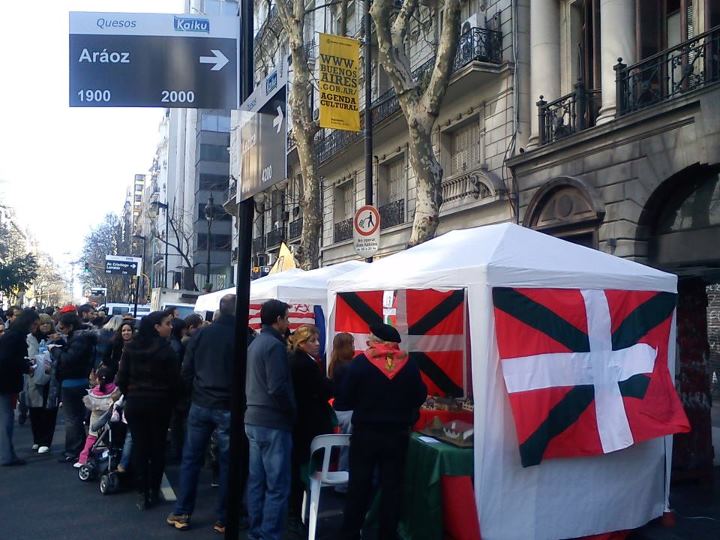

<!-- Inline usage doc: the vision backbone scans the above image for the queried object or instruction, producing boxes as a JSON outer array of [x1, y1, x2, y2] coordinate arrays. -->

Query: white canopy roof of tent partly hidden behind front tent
[[195, 261, 365, 313]]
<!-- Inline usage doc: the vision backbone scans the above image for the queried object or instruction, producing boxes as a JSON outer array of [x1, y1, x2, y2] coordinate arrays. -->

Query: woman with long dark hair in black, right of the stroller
[[115, 311, 182, 510]]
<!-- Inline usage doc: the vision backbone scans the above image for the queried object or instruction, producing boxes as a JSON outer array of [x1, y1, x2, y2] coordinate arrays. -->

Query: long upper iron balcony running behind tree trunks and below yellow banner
[[315, 28, 502, 164]]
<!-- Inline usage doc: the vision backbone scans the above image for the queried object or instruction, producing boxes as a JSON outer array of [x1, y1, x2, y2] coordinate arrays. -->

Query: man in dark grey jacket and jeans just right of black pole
[[245, 300, 297, 540]]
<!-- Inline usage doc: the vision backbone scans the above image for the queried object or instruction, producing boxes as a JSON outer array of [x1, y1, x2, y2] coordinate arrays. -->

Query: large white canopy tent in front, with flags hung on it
[[327, 224, 677, 540]]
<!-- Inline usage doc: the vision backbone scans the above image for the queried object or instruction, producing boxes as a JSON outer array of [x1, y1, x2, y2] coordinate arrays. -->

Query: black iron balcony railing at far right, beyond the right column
[[615, 26, 720, 116]]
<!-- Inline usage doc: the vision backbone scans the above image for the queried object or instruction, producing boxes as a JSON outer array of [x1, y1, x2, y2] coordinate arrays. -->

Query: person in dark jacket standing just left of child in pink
[[50, 313, 97, 463]]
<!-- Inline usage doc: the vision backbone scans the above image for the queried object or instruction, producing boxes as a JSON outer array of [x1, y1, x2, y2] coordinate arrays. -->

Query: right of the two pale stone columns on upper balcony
[[597, 0, 636, 125]]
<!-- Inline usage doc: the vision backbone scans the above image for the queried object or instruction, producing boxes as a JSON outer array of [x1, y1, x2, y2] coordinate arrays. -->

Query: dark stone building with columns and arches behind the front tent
[[509, 0, 720, 477]]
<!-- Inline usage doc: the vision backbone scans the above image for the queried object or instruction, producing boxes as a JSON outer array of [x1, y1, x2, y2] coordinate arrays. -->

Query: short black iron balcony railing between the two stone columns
[[536, 81, 601, 145]]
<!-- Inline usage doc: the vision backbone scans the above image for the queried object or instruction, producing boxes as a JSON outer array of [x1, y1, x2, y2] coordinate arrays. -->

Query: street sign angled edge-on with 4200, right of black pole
[[237, 70, 287, 202]]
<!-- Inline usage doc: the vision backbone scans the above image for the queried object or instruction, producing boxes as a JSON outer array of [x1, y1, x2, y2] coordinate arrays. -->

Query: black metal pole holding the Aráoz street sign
[[225, 0, 255, 540]]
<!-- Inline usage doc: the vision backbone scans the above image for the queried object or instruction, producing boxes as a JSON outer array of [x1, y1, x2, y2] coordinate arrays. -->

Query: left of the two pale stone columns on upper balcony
[[529, 0, 560, 147]]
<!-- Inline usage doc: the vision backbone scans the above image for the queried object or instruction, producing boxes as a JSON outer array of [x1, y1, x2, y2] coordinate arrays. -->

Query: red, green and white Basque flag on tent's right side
[[493, 287, 690, 467]]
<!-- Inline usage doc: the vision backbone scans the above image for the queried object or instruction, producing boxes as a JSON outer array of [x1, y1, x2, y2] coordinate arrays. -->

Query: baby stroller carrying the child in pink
[[78, 403, 126, 495]]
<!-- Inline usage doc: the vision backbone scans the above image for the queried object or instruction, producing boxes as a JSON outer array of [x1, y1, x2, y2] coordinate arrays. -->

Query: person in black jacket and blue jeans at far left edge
[[0, 309, 40, 467]]
